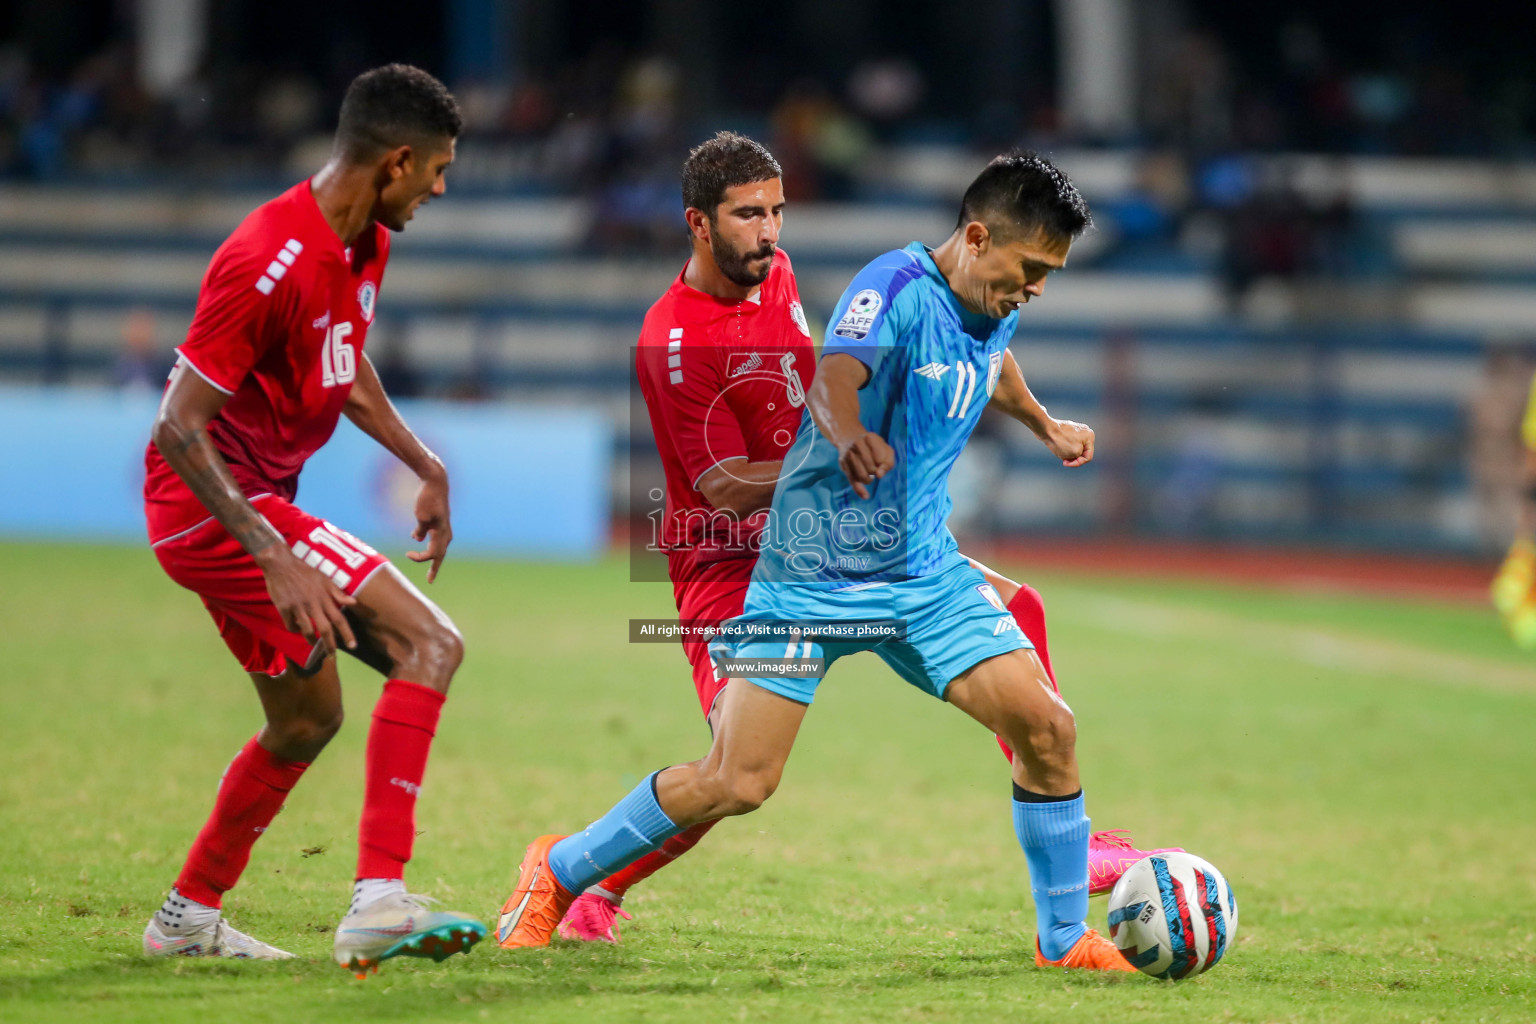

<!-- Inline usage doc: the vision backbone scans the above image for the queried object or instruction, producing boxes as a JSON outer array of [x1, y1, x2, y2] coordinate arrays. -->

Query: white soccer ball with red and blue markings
[[1109, 854, 1238, 981]]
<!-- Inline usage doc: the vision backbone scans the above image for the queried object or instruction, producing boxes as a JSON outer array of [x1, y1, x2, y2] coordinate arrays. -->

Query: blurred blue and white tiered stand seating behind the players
[[0, 146, 1517, 551]]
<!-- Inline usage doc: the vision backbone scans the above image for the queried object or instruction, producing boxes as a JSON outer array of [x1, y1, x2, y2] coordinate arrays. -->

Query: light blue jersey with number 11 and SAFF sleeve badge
[[753, 243, 1018, 588]]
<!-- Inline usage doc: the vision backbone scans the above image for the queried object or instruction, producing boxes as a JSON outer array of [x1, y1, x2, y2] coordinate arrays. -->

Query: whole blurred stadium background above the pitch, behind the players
[[0, 0, 1536, 568]]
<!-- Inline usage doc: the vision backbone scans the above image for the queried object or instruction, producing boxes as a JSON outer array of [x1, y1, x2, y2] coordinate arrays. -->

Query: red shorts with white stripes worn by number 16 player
[[154, 494, 389, 676]]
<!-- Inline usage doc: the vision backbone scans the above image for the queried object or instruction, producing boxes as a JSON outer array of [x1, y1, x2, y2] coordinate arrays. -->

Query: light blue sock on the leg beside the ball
[[1014, 786, 1087, 960]]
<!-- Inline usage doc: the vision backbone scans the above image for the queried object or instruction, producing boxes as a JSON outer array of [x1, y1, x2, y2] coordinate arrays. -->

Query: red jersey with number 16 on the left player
[[144, 181, 390, 540]]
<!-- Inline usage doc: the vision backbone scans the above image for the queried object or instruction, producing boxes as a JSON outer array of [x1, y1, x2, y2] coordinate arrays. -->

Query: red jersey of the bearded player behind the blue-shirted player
[[636, 250, 816, 568]]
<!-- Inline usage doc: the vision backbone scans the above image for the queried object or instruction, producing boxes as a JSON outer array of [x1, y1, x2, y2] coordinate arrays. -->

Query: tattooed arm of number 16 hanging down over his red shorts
[[151, 362, 358, 651]]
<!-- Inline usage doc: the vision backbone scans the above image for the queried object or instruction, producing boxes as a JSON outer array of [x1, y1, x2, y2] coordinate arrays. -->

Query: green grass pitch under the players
[[0, 543, 1536, 1024]]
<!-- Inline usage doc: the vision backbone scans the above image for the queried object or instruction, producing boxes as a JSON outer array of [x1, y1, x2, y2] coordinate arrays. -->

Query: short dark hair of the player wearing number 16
[[336, 64, 464, 163]]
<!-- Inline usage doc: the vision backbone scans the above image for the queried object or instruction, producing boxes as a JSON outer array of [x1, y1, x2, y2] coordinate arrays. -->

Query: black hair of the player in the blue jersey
[[957, 149, 1094, 239]]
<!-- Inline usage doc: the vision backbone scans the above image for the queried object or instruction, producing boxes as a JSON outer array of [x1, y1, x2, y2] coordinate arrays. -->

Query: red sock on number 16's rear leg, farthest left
[[177, 737, 309, 907]]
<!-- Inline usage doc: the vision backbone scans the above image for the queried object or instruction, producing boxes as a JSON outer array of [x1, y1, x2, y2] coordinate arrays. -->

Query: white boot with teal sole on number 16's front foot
[[335, 892, 485, 978]]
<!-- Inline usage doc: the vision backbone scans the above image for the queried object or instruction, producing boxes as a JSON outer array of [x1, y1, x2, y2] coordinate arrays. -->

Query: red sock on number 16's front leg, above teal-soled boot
[[358, 679, 444, 878]]
